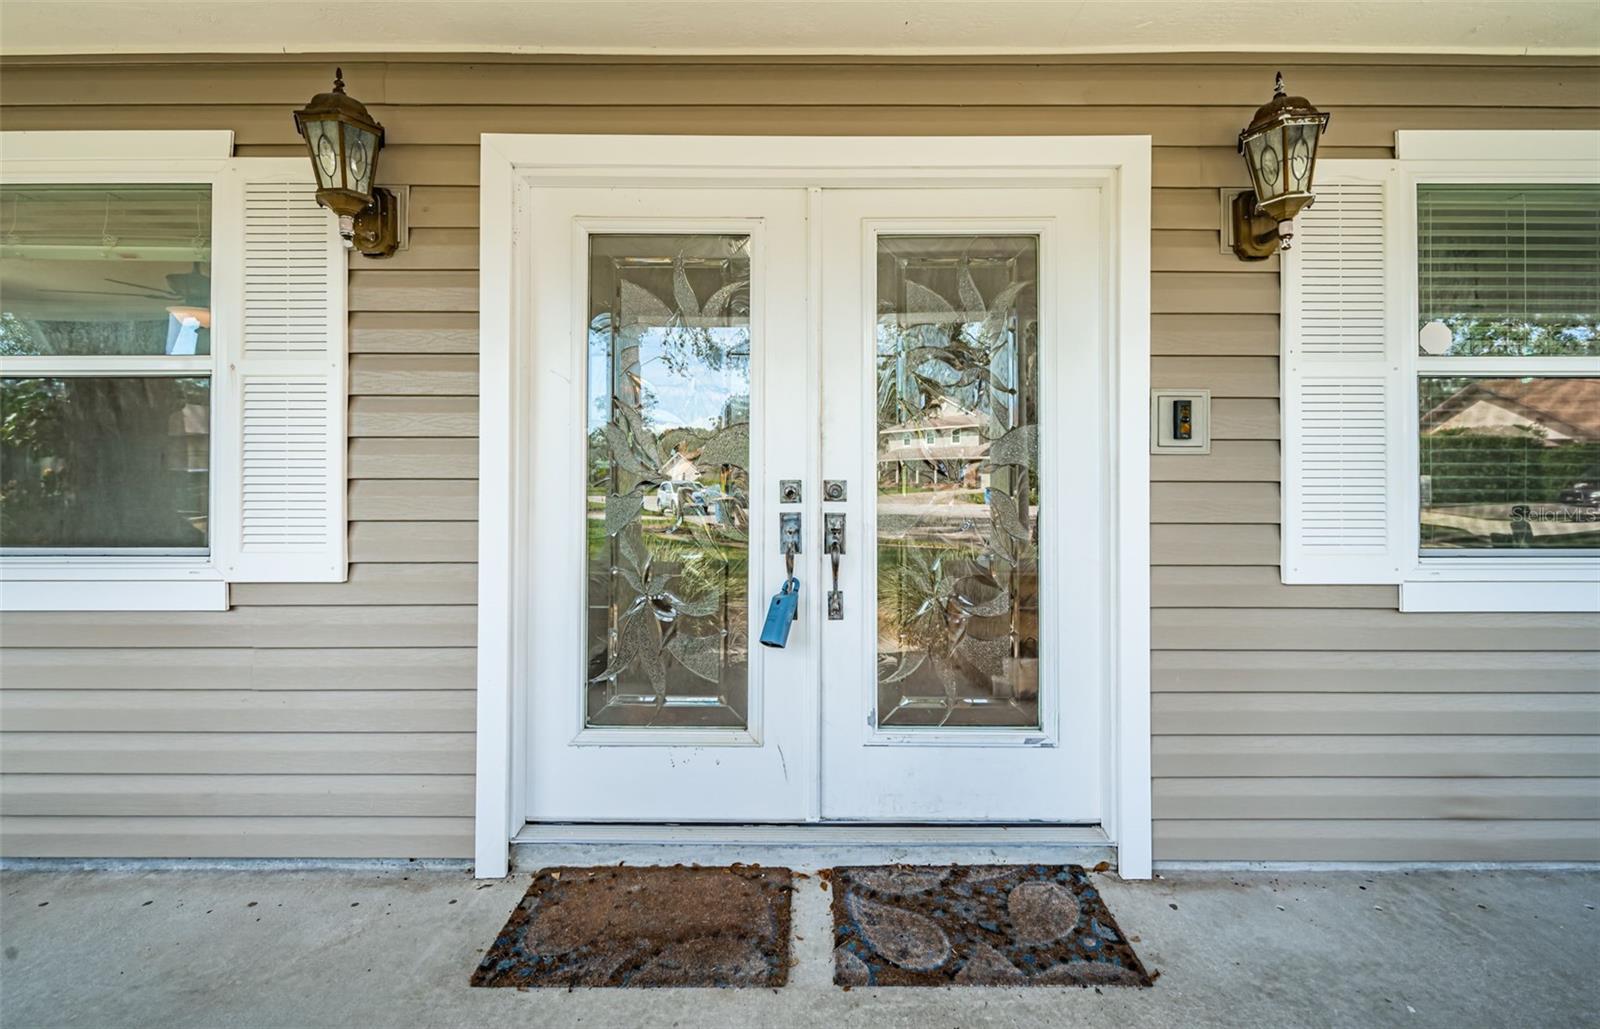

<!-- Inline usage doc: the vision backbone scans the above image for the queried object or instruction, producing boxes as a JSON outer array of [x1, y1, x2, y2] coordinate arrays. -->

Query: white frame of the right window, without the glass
[[1387, 148, 1600, 611]]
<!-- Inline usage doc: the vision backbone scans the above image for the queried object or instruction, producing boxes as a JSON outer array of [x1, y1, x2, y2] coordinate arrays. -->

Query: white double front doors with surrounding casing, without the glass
[[477, 136, 1149, 877]]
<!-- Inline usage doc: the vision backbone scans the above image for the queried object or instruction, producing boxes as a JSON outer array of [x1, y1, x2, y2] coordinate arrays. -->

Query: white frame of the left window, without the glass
[[0, 130, 243, 611]]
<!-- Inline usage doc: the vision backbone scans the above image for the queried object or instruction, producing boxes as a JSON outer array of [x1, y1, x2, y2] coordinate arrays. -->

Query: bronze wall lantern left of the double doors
[[294, 69, 400, 258]]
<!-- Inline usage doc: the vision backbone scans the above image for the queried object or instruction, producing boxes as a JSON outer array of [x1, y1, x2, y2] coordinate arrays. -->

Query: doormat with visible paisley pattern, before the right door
[[829, 864, 1150, 986]]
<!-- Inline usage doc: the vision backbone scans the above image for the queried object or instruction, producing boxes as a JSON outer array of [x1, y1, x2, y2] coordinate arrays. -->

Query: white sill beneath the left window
[[0, 559, 227, 611]]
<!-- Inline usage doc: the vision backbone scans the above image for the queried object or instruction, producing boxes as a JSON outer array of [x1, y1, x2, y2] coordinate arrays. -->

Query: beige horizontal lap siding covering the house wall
[[0, 56, 1600, 859]]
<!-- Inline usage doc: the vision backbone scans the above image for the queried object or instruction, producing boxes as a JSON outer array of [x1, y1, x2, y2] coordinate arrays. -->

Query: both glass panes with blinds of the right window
[[1416, 182, 1600, 557]]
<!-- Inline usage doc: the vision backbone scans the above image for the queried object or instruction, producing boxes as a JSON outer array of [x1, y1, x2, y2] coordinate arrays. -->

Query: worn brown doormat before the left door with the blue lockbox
[[472, 864, 794, 987]]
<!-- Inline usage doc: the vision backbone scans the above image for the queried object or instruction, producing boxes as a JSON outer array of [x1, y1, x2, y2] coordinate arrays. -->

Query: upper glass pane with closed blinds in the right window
[[1416, 182, 1600, 357]]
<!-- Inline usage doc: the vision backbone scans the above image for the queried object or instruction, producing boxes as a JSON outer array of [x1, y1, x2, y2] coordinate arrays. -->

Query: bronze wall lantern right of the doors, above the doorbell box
[[1232, 72, 1333, 261]]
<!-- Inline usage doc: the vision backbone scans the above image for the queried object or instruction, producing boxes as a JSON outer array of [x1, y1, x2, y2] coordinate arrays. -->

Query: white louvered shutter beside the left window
[[218, 158, 347, 583]]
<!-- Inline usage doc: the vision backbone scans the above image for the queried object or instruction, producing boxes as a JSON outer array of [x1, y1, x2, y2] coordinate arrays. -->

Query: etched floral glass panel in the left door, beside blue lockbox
[[585, 235, 752, 728]]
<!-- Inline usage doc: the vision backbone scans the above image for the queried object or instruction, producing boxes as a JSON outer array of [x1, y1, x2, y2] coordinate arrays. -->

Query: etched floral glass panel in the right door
[[877, 235, 1040, 728]]
